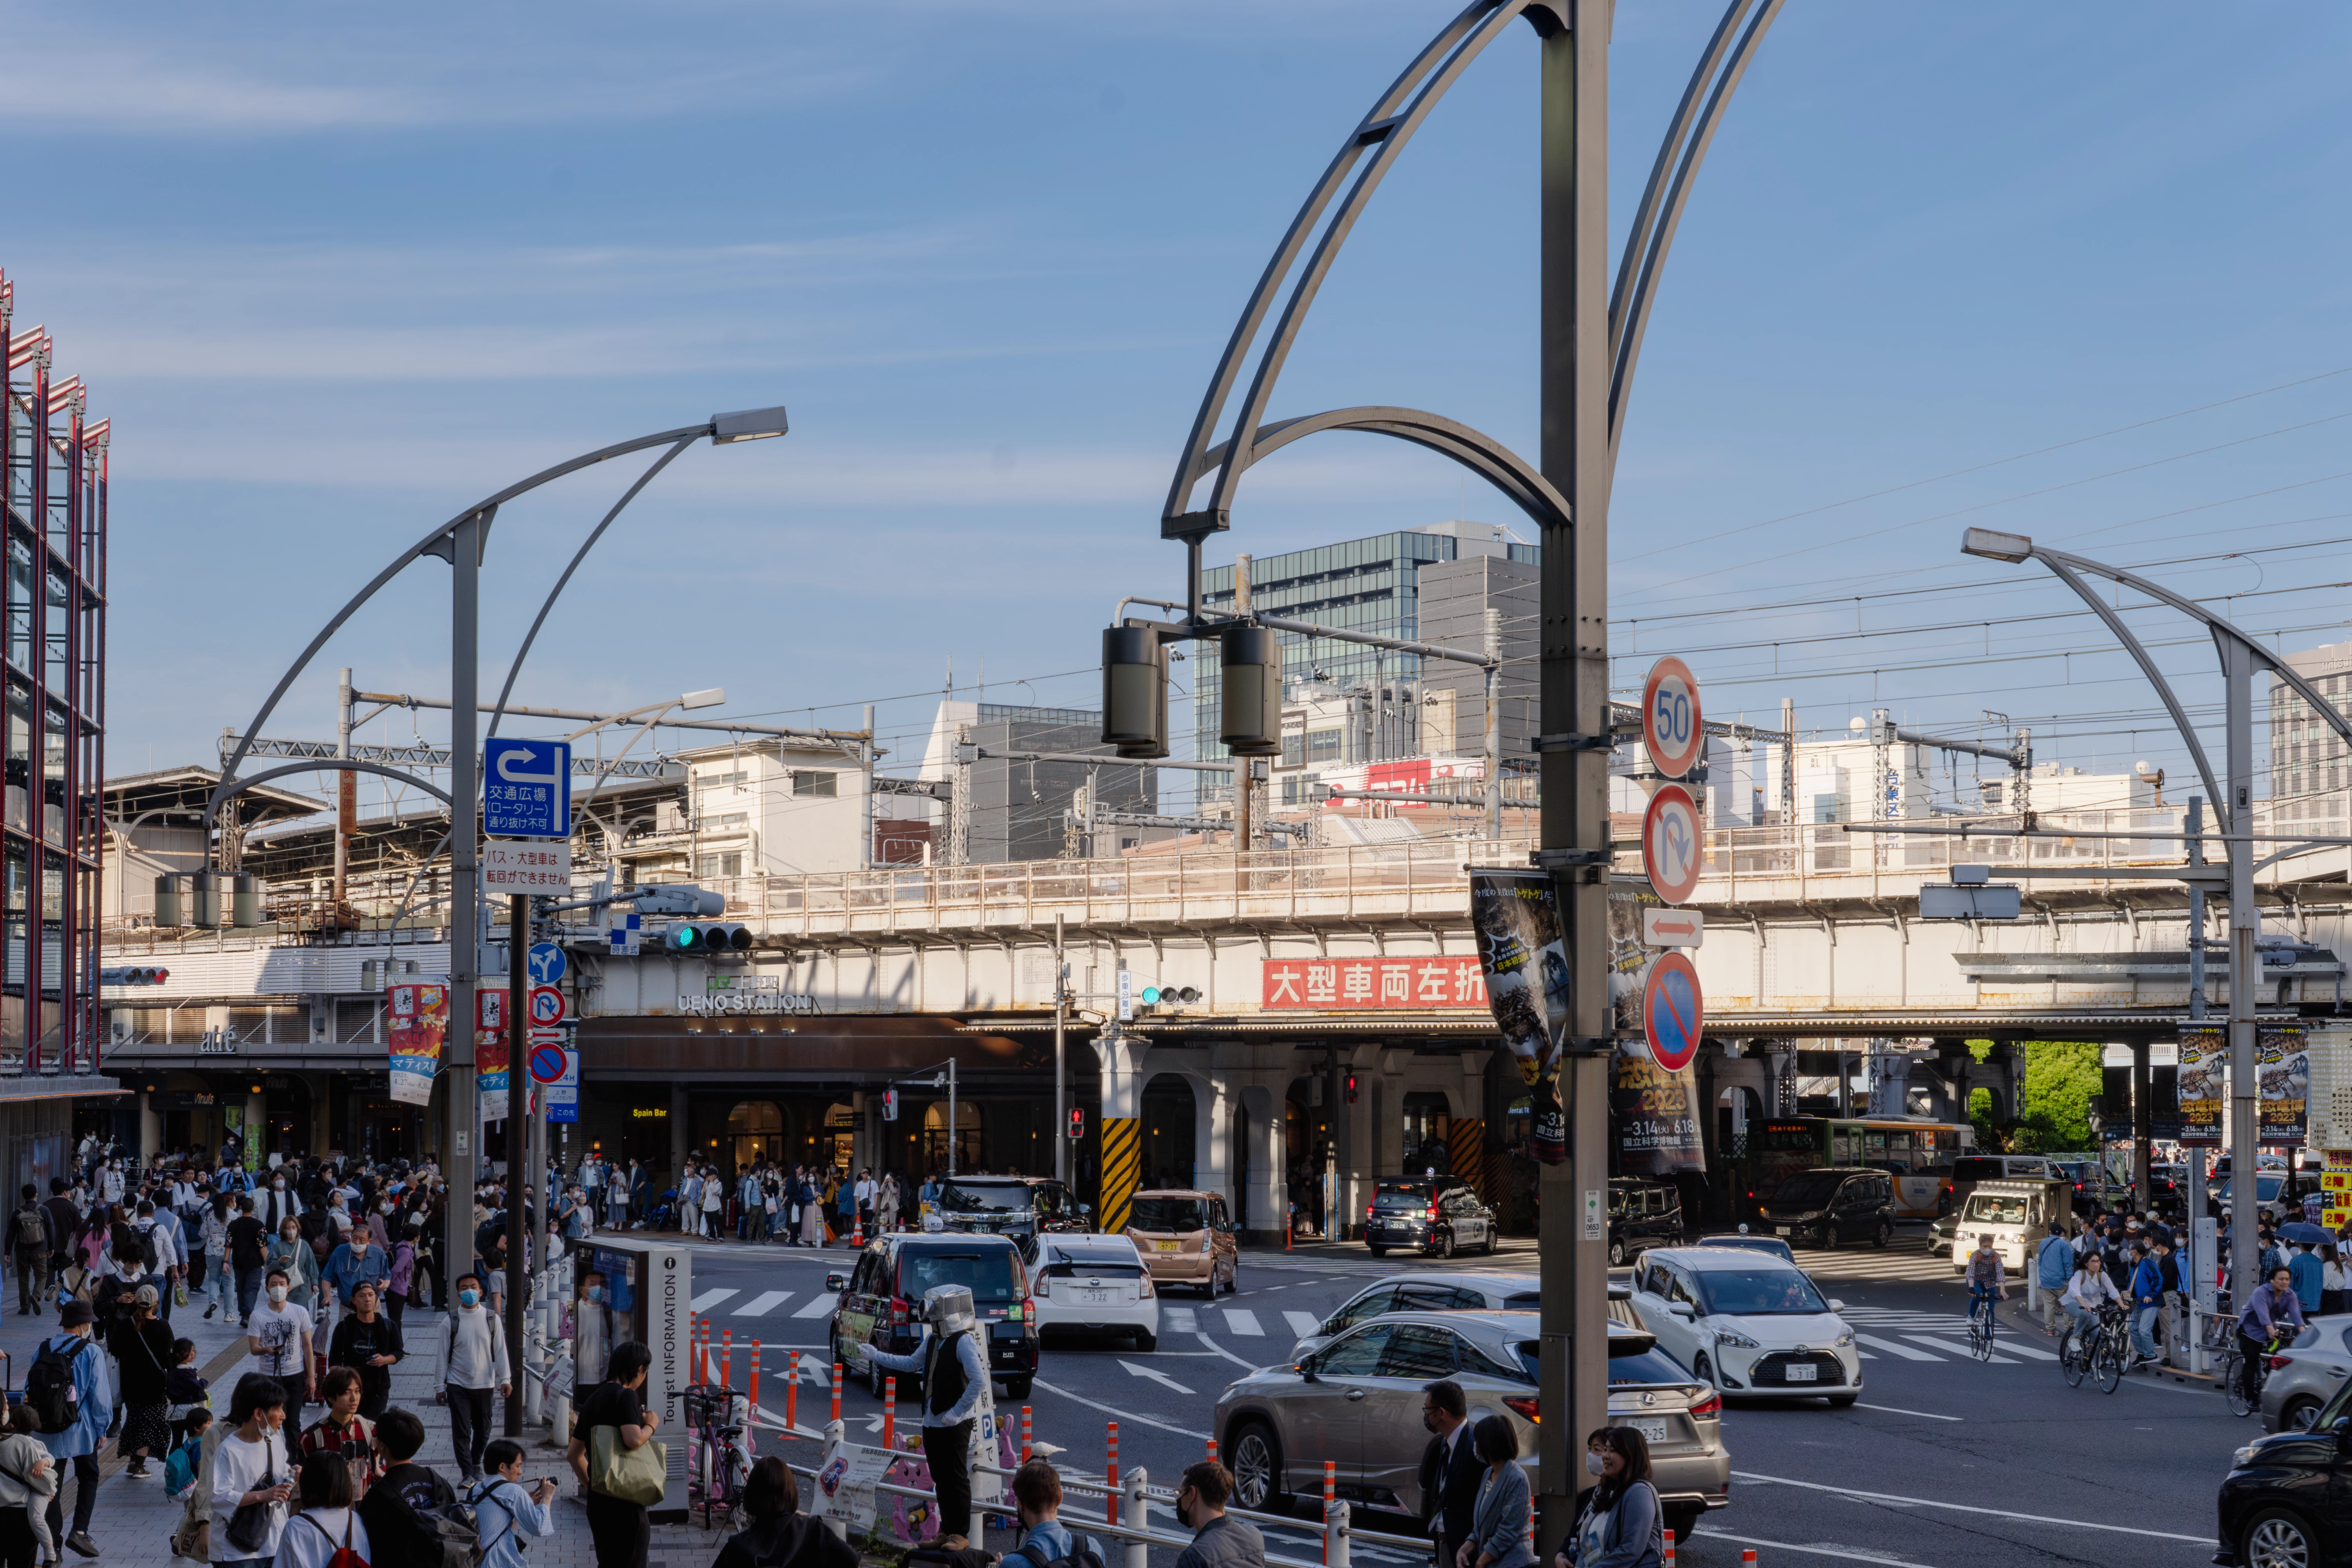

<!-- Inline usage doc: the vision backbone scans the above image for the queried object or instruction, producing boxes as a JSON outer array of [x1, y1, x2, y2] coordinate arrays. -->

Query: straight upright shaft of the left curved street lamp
[[442, 512, 482, 1269]]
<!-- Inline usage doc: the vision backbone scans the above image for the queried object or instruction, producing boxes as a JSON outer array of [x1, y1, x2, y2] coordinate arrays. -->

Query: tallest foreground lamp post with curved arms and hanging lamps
[[1105, 0, 1780, 1554]]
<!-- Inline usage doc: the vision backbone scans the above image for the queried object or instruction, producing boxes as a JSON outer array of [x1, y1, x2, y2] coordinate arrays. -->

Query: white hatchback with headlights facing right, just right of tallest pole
[[1632, 1246, 1863, 1406]]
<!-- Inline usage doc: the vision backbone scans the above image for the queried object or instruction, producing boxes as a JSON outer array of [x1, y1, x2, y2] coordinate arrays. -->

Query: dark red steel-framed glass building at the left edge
[[0, 273, 106, 1074]]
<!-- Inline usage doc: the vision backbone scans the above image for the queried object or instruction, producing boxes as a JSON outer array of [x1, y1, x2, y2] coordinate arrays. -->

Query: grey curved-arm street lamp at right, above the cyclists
[[1959, 529, 2352, 1309]]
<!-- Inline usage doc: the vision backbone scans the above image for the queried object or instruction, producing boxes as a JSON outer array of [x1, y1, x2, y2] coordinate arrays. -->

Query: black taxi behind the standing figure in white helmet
[[826, 1234, 1037, 1399]]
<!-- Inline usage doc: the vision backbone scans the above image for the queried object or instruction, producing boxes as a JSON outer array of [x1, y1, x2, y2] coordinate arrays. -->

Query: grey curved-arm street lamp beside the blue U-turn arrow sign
[[205, 407, 788, 1345]]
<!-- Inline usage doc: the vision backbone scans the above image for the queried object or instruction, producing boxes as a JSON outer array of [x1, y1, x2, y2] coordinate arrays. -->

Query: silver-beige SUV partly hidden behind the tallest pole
[[1216, 1312, 1731, 1540]]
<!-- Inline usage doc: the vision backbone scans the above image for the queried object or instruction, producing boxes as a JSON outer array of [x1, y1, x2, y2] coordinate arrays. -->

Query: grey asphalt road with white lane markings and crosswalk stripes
[[659, 1227, 2260, 1568]]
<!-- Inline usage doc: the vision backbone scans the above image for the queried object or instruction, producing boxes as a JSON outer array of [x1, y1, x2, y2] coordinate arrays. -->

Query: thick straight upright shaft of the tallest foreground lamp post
[[1538, 0, 1613, 1561]]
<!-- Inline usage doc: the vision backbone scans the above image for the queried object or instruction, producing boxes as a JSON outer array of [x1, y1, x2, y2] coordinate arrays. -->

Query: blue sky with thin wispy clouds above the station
[[18, 0, 2352, 808]]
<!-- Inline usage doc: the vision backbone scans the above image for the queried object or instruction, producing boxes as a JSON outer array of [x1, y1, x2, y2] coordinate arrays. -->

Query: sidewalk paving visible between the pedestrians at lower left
[[0, 1276, 946, 1568]]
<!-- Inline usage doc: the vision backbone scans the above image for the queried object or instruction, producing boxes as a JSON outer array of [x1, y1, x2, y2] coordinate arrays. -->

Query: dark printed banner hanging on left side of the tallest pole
[[1470, 867, 1569, 1166]]
